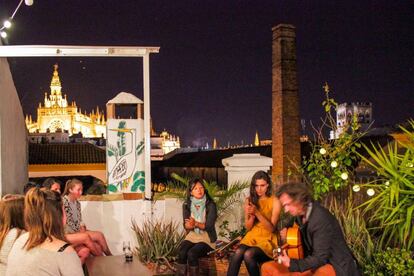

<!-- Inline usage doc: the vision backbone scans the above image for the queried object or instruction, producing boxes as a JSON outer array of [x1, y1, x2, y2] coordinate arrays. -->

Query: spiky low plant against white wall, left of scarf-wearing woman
[[132, 220, 185, 266]]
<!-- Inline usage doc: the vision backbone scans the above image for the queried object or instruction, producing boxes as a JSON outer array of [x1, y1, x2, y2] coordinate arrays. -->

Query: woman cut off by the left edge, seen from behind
[[0, 195, 24, 275]]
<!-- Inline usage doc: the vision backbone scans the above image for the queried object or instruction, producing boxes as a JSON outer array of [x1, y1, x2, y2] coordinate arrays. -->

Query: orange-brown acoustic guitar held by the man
[[273, 224, 304, 259]]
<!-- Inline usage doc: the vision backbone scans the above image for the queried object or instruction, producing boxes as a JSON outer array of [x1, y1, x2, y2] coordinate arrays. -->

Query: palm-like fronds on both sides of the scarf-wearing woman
[[160, 173, 249, 218]]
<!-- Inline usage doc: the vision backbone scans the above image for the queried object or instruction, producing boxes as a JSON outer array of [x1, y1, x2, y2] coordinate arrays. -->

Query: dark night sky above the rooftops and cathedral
[[0, 0, 414, 146]]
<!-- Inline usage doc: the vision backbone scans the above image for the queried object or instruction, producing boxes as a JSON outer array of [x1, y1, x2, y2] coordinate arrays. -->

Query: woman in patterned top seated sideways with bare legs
[[63, 178, 112, 256]]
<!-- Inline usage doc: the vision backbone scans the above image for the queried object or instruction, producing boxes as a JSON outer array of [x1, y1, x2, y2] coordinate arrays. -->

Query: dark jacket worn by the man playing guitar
[[289, 202, 361, 276]]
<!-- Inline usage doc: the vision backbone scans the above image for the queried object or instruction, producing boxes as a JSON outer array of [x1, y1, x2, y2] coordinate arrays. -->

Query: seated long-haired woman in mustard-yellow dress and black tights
[[227, 171, 281, 276]]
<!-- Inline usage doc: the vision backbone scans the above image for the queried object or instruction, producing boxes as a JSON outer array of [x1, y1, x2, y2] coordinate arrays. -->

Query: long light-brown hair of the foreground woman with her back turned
[[24, 188, 65, 250]]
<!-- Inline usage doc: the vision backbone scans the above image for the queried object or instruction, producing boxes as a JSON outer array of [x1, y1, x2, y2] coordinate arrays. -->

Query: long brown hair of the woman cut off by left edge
[[0, 195, 24, 248]]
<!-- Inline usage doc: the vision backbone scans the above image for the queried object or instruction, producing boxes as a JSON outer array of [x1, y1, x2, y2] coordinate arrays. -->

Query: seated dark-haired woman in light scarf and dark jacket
[[176, 179, 217, 276]]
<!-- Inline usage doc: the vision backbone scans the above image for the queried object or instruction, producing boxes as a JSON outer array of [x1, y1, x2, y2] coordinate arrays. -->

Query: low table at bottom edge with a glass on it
[[86, 255, 152, 276]]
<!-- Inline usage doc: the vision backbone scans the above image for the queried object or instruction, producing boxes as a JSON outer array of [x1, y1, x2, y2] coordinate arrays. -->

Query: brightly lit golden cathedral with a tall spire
[[26, 64, 106, 137]]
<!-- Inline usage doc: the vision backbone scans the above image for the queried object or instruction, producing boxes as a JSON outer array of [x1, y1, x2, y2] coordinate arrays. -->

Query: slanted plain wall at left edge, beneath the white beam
[[0, 51, 28, 195]]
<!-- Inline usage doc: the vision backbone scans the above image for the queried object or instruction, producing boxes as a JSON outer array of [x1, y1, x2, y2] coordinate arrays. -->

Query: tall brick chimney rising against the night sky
[[272, 24, 301, 184]]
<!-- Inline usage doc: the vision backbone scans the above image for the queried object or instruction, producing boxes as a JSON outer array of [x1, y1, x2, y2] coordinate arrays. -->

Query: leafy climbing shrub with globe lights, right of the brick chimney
[[299, 84, 364, 199]]
